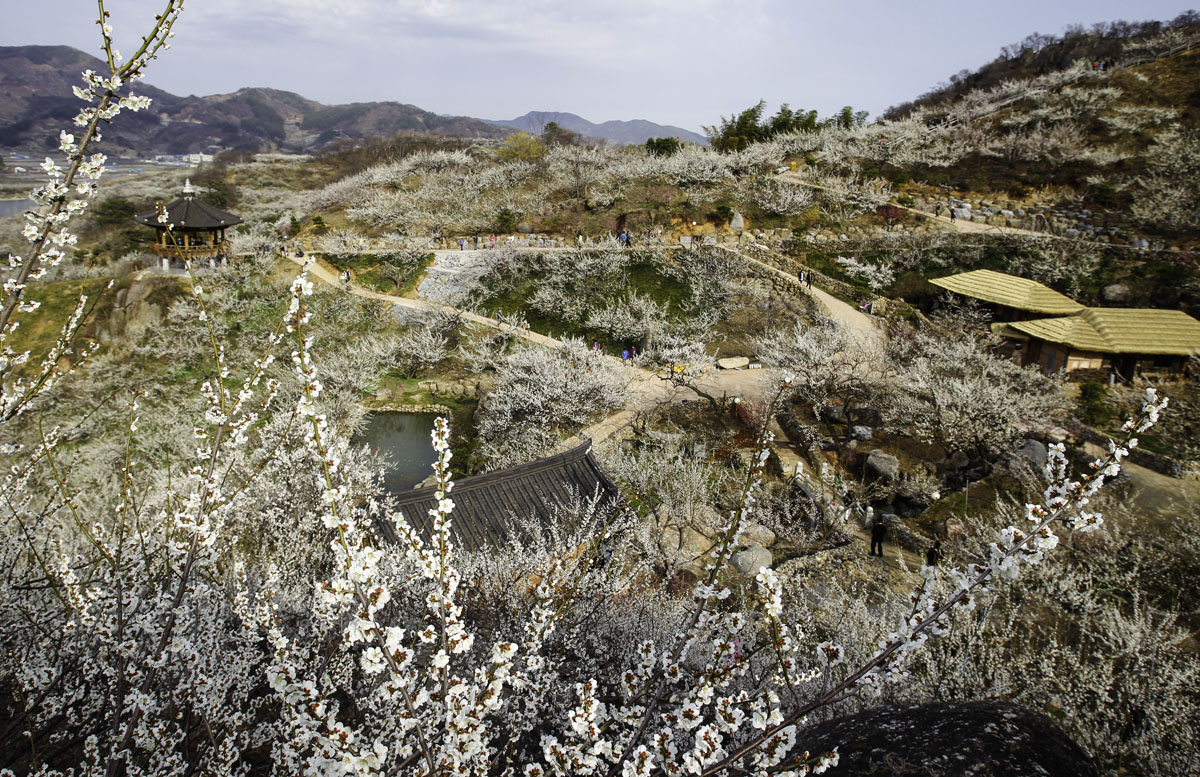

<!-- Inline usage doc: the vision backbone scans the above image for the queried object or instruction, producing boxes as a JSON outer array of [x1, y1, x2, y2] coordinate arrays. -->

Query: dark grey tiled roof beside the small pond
[[379, 441, 619, 549]]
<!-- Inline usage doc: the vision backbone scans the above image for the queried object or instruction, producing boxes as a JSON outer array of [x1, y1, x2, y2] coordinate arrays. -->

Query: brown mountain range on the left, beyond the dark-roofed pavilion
[[0, 46, 508, 155]]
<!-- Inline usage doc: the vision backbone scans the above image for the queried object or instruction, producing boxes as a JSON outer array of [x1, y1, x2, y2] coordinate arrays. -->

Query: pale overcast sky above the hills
[[0, 0, 1196, 131]]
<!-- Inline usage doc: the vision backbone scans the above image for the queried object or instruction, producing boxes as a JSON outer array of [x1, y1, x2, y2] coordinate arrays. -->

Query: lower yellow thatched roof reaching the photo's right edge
[[1009, 308, 1200, 356]]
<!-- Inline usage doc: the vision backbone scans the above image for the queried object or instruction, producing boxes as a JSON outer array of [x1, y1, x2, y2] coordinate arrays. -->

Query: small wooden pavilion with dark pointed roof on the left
[[133, 180, 241, 270]]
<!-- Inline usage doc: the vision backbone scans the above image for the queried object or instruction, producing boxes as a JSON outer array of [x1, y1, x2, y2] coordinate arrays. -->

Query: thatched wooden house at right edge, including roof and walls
[[995, 308, 1200, 380]]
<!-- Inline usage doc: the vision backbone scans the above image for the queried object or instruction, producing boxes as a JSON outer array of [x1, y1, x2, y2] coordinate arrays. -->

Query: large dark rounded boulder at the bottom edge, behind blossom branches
[[796, 701, 1097, 777]]
